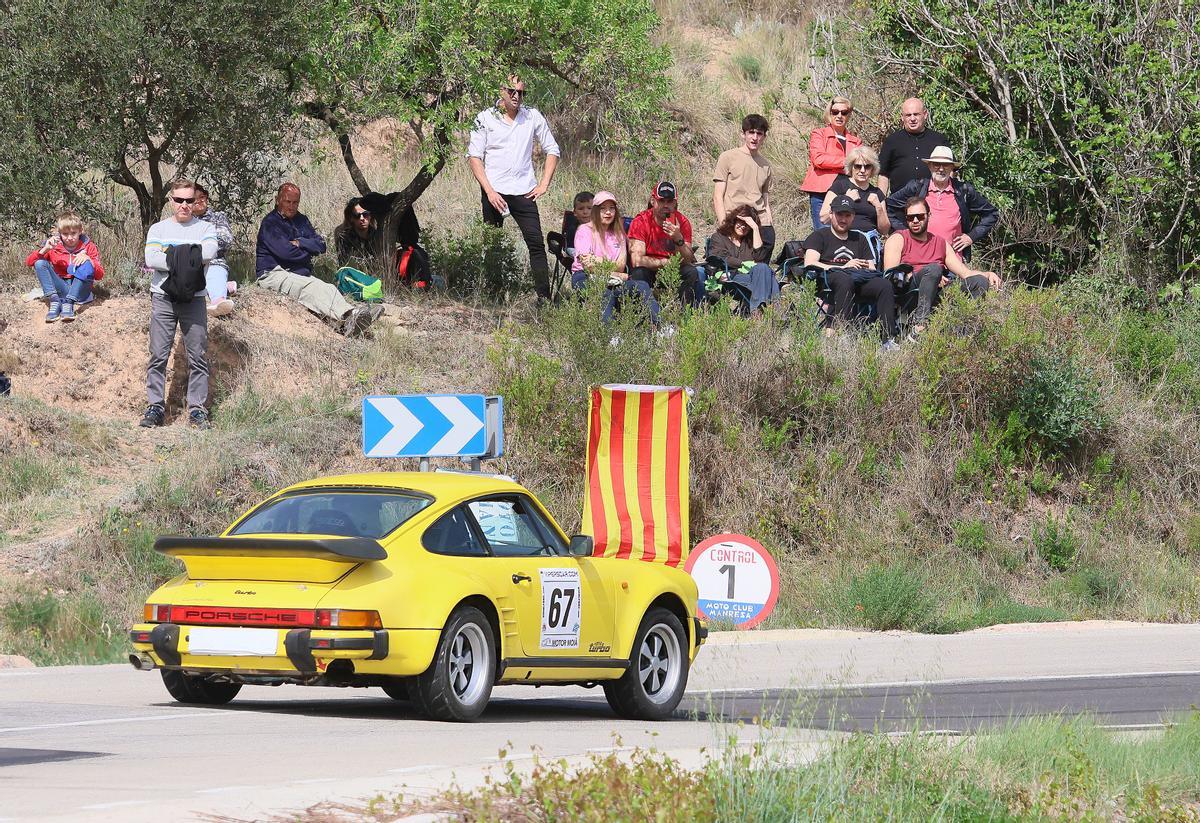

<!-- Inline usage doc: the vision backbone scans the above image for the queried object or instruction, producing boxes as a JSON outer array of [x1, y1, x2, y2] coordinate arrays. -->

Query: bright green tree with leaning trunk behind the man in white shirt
[[290, 0, 670, 263]]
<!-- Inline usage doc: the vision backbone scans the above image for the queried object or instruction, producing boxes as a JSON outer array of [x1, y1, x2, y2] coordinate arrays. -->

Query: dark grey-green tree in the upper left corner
[[0, 0, 301, 235]]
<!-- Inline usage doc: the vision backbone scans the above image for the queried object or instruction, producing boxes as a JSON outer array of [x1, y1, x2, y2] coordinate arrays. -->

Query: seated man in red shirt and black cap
[[629, 180, 704, 306]]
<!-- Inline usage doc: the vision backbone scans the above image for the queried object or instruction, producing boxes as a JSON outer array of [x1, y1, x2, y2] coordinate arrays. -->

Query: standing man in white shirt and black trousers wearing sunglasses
[[467, 74, 559, 300]]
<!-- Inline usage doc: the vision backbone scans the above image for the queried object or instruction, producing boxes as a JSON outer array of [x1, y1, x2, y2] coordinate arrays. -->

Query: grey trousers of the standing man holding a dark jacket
[[146, 294, 209, 409]]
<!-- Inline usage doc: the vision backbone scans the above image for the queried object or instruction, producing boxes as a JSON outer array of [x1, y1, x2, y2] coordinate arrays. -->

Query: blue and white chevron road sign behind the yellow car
[[362, 395, 503, 457]]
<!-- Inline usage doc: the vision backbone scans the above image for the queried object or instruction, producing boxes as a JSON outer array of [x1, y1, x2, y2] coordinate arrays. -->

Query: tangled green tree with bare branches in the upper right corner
[[874, 0, 1200, 287]]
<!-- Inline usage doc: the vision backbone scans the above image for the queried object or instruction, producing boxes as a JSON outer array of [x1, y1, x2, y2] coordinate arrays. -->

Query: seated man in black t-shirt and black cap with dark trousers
[[804, 194, 899, 350]]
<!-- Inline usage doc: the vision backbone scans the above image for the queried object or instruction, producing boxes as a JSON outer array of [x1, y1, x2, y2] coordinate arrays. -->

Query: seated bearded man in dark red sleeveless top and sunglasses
[[883, 197, 1000, 338]]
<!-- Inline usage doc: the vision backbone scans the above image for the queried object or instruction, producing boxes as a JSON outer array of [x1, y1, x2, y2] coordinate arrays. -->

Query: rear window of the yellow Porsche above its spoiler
[[229, 489, 433, 539]]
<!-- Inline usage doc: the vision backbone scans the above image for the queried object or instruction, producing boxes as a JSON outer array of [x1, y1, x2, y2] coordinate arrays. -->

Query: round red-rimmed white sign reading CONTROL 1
[[684, 534, 779, 629]]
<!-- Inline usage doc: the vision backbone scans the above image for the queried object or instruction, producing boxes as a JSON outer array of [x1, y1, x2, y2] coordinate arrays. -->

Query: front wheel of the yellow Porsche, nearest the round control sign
[[604, 608, 688, 720]]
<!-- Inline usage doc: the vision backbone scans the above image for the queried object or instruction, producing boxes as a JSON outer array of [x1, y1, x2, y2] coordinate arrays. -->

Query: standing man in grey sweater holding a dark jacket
[[139, 179, 217, 428]]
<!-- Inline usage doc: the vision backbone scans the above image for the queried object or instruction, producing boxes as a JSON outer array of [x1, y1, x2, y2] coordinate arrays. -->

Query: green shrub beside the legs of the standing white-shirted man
[[426, 220, 527, 301]]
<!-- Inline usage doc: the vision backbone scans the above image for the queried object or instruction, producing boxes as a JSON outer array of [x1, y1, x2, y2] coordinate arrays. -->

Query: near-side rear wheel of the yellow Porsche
[[408, 606, 496, 722]]
